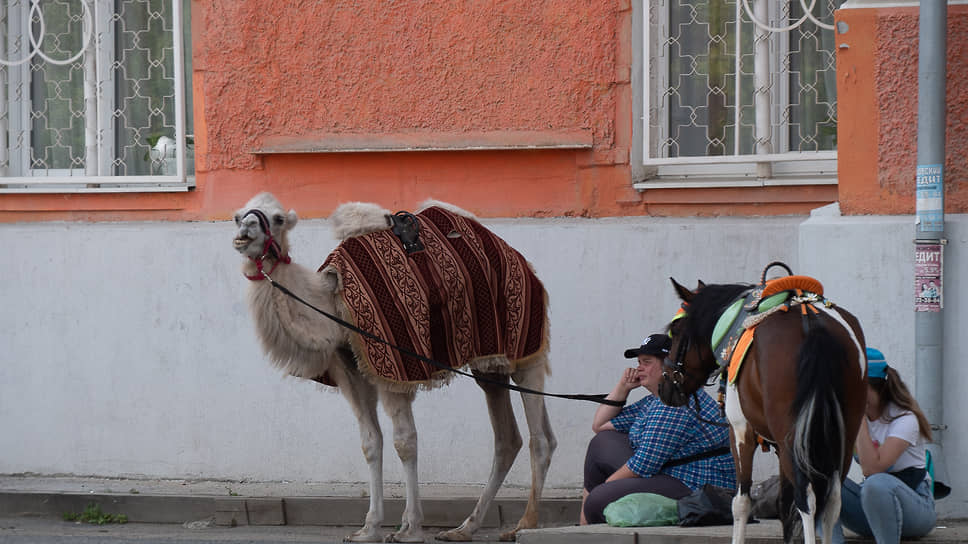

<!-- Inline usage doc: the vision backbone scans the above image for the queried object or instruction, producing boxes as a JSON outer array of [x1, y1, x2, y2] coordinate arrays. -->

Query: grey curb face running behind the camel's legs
[[0, 491, 581, 527]]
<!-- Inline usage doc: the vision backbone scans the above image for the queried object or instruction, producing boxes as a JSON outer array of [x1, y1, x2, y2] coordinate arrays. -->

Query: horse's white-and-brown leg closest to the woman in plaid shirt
[[726, 385, 756, 544]]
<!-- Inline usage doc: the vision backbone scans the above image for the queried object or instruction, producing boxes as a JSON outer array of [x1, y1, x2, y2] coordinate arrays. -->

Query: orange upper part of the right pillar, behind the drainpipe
[[837, 5, 968, 215]]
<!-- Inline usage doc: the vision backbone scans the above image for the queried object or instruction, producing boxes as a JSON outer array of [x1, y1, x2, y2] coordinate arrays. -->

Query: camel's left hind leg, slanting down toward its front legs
[[437, 374, 521, 542]]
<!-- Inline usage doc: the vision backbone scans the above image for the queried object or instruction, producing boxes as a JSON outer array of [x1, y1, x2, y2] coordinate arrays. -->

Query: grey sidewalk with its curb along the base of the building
[[0, 475, 968, 544]]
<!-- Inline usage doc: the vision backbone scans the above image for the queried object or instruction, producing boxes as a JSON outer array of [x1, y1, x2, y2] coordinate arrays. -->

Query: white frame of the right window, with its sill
[[633, 0, 837, 190]]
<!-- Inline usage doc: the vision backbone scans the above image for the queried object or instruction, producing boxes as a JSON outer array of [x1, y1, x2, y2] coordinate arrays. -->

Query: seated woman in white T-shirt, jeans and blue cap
[[833, 348, 937, 544]]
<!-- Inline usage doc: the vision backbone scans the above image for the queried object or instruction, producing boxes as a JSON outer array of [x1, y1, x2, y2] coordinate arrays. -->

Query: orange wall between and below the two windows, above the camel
[[0, 0, 837, 222]]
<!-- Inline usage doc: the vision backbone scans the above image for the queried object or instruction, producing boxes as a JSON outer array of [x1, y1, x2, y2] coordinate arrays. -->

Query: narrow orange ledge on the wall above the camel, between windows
[[250, 129, 594, 155]]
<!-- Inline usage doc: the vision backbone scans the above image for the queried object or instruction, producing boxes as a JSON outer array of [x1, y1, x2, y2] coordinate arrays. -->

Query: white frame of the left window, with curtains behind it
[[0, 0, 195, 193]]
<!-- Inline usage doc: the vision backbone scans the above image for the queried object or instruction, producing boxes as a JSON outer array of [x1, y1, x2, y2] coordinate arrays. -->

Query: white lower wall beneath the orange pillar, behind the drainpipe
[[799, 205, 968, 518]]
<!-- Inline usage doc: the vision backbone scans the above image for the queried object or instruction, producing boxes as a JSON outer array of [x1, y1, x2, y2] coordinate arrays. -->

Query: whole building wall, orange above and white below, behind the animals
[[0, 0, 968, 517]]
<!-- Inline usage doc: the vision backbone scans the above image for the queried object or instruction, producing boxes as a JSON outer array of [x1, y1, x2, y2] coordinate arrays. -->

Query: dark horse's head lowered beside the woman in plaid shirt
[[659, 278, 715, 406]]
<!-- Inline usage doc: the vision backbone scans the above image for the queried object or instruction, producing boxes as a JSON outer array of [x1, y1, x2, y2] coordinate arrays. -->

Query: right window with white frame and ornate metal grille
[[636, 0, 839, 188]]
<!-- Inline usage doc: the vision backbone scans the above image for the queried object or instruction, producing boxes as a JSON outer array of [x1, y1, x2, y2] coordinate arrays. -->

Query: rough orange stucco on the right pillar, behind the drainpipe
[[874, 11, 968, 213]]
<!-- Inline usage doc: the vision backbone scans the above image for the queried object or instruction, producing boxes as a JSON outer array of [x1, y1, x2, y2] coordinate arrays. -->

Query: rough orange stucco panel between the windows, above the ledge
[[195, 0, 622, 170]]
